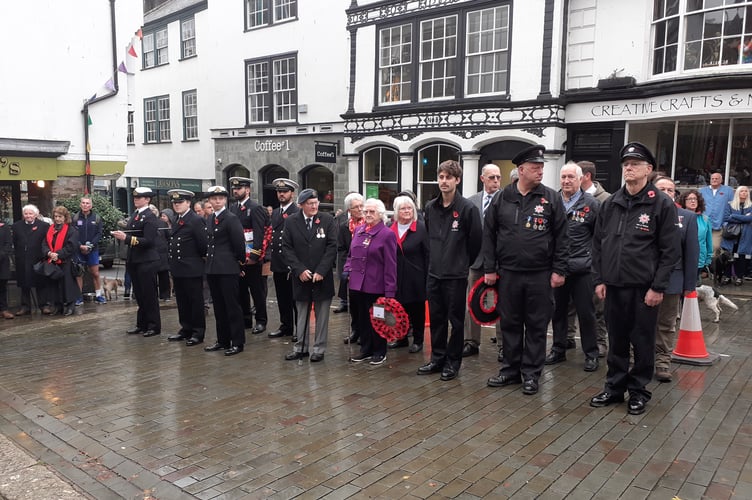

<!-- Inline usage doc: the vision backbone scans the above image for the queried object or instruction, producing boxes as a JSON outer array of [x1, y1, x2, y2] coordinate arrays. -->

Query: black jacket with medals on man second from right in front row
[[483, 181, 569, 276]]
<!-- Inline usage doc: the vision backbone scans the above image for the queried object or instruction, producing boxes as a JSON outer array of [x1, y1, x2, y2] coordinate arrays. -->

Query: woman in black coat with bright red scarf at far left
[[42, 206, 81, 316]]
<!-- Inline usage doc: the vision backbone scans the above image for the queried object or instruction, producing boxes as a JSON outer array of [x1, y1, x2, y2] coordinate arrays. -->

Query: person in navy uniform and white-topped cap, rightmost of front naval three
[[204, 186, 245, 356]]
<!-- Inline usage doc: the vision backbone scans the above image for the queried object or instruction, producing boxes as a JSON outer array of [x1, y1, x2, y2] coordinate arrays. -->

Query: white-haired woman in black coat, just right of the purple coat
[[389, 196, 429, 352]]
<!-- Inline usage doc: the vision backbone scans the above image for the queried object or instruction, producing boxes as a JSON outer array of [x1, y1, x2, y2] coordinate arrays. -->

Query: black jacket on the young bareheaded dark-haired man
[[424, 191, 483, 279]]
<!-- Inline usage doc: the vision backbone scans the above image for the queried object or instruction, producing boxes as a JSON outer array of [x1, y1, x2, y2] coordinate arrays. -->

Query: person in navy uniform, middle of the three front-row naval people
[[167, 189, 208, 346]]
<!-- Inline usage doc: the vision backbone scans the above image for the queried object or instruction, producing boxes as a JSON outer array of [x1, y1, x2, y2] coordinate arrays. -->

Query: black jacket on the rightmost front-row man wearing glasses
[[593, 183, 681, 292]]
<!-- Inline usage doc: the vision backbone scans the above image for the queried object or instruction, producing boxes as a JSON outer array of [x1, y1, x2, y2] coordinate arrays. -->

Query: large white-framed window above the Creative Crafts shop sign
[[652, 0, 752, 75]]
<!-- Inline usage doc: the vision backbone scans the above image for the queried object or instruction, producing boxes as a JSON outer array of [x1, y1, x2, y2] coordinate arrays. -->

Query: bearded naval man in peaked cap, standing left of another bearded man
[[230, 177, 271, 334]]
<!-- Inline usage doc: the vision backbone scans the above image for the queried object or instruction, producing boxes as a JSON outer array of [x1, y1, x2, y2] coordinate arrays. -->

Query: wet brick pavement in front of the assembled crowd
[[0, 270, 752, 499]]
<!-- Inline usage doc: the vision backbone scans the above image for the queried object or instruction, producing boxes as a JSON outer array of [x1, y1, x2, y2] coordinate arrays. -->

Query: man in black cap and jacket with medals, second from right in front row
[[483, 145, 569, 395]]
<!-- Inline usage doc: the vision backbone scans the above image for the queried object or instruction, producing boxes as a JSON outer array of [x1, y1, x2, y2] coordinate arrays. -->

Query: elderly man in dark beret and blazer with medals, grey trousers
[[282, 189, 337, 363]]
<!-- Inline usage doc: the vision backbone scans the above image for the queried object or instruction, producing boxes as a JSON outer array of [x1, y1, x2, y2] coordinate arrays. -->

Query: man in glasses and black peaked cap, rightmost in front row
[[590, 142, 681, 415]]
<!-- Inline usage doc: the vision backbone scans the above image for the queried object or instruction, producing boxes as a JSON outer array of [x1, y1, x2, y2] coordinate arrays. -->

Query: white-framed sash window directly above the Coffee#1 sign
[[246, 56, 298, 124]]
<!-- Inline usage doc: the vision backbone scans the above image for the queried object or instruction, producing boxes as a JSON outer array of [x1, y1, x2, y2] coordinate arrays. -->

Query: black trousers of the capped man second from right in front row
[[499, 270, 552, 380]]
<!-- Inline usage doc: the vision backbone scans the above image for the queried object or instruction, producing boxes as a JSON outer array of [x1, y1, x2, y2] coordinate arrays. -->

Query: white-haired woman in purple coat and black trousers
[[343, 198, 397, 365]]
